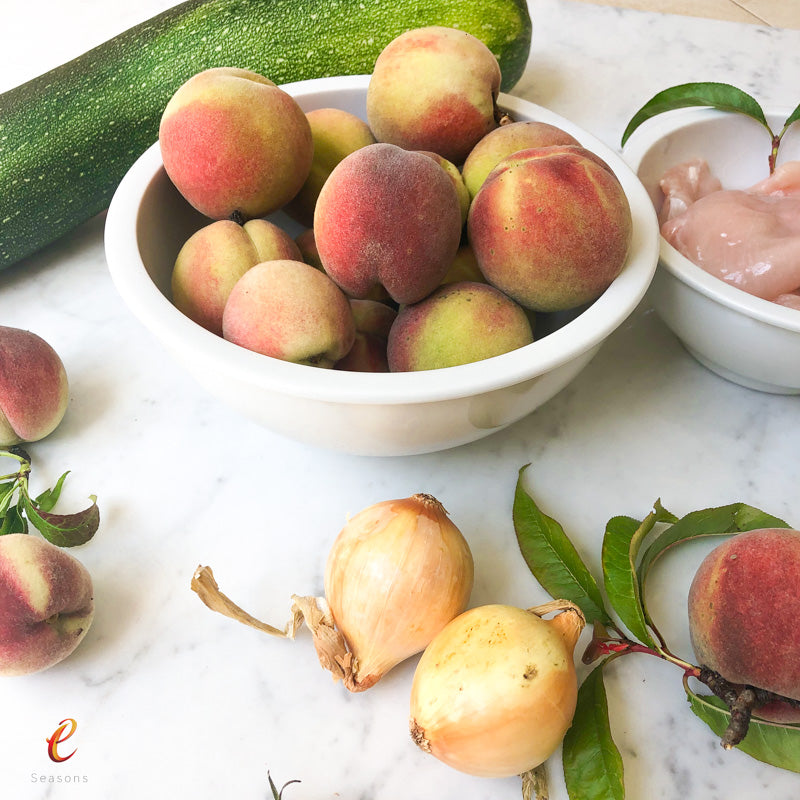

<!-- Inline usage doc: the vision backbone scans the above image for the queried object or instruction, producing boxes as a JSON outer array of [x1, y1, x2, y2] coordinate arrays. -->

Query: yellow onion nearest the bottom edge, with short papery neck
[[410, 601, 584, 778]]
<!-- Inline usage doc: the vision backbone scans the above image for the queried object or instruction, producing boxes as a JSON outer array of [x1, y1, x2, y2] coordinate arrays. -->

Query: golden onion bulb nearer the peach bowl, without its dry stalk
[[325, 494, 474, 691]]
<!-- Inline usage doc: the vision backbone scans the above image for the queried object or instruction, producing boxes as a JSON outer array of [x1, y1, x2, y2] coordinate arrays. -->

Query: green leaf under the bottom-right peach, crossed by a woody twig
[[684, 681, 800, 772]]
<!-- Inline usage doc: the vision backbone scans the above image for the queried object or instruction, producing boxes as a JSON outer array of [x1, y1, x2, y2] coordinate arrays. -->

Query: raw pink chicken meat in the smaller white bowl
[[661, 161, 800, 300]]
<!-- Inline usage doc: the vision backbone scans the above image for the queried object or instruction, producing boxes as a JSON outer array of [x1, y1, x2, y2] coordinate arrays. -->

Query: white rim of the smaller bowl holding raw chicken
[[622, 106, 800, 333]]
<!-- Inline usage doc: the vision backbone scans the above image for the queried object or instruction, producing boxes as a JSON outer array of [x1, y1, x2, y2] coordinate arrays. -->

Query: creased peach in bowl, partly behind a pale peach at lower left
[[172, 219, 302, 336]]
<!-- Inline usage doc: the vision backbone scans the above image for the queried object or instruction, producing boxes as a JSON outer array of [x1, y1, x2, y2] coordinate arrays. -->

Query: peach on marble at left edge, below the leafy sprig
[[0, 533, 94, 675]]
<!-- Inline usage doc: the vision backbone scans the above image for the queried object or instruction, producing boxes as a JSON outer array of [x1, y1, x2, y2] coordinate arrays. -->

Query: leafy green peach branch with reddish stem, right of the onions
[[513, 466, 800, 800]]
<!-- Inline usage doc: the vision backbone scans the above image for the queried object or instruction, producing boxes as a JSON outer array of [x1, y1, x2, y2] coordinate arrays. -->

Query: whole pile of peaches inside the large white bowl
[[159, 26, 632, 372]]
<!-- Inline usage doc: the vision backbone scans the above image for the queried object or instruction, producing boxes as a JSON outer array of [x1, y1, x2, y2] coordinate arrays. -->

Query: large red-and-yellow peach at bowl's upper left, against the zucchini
[[159, 67, 313, 219]]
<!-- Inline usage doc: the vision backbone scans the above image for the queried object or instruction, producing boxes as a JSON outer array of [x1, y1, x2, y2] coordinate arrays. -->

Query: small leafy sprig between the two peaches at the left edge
[[0, 446, 100, 547]]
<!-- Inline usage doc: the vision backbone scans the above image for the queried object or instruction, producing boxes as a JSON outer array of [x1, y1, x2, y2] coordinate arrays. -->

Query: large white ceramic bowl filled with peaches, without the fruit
[[105, 75, 658, 455]]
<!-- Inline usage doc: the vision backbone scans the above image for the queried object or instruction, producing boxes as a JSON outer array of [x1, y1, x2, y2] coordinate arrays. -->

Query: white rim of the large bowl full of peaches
[[105, 75, 658, 405]]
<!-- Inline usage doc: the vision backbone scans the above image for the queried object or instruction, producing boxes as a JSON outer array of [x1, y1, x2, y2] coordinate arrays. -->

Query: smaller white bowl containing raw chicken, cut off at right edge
[[623, 108, 800, 394]]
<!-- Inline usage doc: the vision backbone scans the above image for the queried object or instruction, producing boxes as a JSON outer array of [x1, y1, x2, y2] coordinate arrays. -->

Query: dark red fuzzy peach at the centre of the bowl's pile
[[314, 143, 462, 303]]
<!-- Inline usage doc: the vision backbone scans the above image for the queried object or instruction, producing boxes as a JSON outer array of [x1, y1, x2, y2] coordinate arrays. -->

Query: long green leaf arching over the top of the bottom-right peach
[[638, 503, 792, 596]]
